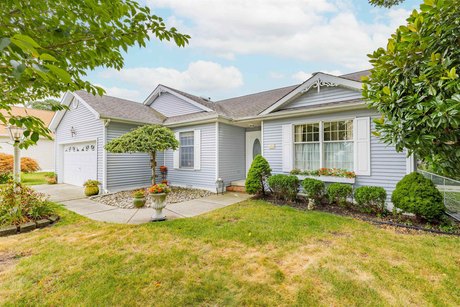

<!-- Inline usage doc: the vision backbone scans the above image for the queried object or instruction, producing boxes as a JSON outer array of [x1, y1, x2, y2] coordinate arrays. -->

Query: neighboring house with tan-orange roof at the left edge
[[0, 107, 55, 171]]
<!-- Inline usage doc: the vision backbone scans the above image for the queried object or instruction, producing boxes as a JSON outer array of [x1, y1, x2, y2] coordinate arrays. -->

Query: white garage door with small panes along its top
[[63, 142, 97, 186]]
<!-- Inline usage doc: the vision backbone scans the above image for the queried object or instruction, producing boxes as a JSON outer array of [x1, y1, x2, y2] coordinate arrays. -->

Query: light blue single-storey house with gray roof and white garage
[[50, 71, 414, 200]]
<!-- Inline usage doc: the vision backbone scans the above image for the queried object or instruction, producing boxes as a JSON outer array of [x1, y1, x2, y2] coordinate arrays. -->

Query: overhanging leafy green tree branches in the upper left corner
[[0, 0, 189, 147]]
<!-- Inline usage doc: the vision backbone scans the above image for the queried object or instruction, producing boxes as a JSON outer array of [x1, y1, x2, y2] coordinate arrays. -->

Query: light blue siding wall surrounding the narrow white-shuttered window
[[159, 123, 217, 191]]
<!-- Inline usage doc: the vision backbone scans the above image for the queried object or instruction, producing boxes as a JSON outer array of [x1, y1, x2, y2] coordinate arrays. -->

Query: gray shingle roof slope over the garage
[[75, 91, 166, 124]]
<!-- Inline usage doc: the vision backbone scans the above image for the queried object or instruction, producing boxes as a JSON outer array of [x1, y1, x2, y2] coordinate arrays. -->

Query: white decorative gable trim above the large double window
[[260, 72, 362, 115]]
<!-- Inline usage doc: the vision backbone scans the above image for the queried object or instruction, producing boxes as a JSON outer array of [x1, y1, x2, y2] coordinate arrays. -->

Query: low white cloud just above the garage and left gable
[[100, 61, 243, 95]]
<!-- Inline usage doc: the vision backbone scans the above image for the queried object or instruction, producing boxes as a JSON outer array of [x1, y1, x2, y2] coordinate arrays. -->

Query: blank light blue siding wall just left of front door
[[218, 123, 246, 185]]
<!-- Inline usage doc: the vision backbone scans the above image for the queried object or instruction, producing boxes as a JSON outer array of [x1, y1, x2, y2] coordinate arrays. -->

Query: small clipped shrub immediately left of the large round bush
[[355, 186, 387, 213]]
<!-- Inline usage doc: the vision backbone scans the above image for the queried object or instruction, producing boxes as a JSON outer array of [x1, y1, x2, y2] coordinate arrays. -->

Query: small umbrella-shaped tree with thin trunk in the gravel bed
[[105, 125, 179, 184]]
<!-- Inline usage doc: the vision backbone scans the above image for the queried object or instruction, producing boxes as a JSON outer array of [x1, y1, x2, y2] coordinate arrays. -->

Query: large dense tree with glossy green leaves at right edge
[[363, 0, 460, 175]]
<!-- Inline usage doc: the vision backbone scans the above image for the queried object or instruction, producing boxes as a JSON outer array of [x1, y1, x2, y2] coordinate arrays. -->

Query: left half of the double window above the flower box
[[294, 124, 320, 170]]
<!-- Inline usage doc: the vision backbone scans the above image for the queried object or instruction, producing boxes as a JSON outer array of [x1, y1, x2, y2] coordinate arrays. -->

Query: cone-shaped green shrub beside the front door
[[245, 155, 272, 195]]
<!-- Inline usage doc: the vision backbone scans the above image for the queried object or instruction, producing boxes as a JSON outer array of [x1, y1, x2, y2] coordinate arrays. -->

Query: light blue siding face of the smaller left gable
[[151, 93, 203, 117]]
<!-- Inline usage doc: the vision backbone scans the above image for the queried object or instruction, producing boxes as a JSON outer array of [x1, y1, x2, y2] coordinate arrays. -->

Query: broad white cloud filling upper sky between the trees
[[147, 0, 409, 70]]
